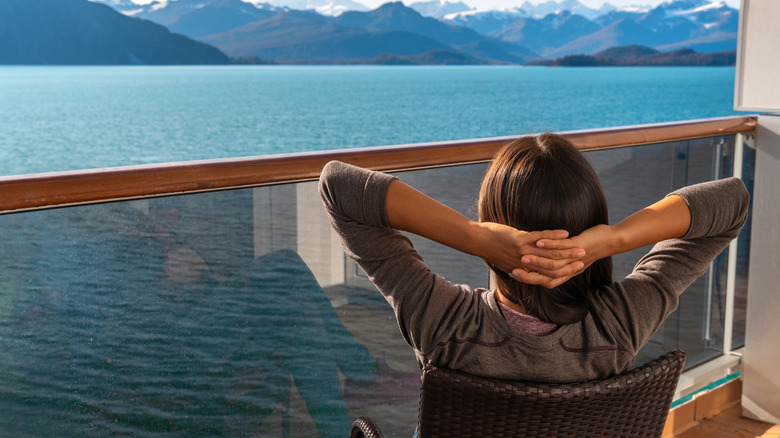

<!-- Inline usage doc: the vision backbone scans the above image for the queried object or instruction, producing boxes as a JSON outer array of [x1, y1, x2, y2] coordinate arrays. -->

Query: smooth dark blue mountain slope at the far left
[[0, 0, 230, 65]]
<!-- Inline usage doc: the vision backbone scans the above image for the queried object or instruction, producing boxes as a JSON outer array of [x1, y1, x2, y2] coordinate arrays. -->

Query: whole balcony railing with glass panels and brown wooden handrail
[[0, 117, 756, 436]]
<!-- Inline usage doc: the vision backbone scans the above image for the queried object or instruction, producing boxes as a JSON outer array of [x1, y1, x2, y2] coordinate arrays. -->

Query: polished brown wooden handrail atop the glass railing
[[0, 116, 757, 213]]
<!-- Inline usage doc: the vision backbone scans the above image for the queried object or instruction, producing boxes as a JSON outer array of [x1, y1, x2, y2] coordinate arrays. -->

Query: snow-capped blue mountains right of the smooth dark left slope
[[100, 0, 739, 64]]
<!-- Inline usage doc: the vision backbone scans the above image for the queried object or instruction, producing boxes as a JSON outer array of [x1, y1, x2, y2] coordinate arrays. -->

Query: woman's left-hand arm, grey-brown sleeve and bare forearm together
[[319, 161, 581, 355]]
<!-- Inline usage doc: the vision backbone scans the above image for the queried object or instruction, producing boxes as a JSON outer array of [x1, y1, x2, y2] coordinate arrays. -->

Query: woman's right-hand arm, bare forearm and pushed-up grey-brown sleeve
[[524, 178, 749, 351]]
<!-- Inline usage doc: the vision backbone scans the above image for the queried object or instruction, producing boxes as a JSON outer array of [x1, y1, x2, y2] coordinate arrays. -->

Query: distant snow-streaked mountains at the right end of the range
[[442, 0, 739, 58]]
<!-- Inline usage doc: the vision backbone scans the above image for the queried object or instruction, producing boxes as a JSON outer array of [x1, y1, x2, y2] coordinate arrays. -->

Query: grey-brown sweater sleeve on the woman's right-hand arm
[[593, 178, 749, 354]]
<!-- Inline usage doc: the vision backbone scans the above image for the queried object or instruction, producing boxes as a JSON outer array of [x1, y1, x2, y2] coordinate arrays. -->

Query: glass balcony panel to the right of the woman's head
[[585, 136, 734, 367]]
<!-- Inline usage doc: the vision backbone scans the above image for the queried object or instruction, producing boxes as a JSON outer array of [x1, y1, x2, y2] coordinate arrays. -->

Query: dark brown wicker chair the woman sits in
[[350, 350, 685, 438]]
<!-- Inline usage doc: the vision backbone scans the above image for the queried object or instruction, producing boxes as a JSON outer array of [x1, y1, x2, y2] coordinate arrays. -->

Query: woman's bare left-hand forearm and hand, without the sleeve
[[385, 180, 585, 285]]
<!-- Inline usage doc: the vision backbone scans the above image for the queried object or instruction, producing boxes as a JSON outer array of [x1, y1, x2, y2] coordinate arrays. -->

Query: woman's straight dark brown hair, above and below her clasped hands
[[479, 134, 612, 324]]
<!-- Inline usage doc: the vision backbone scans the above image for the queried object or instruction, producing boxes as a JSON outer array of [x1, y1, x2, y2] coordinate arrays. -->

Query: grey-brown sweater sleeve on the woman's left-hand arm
[[319, 161, 474, 355]]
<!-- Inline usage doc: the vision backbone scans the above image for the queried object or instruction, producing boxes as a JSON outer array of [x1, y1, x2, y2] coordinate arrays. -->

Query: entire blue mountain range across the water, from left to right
[[0, 0, 738, 64]]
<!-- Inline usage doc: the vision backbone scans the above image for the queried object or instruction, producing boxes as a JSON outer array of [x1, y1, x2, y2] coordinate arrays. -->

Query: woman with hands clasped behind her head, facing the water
[[320, 134, 748, 382]]
